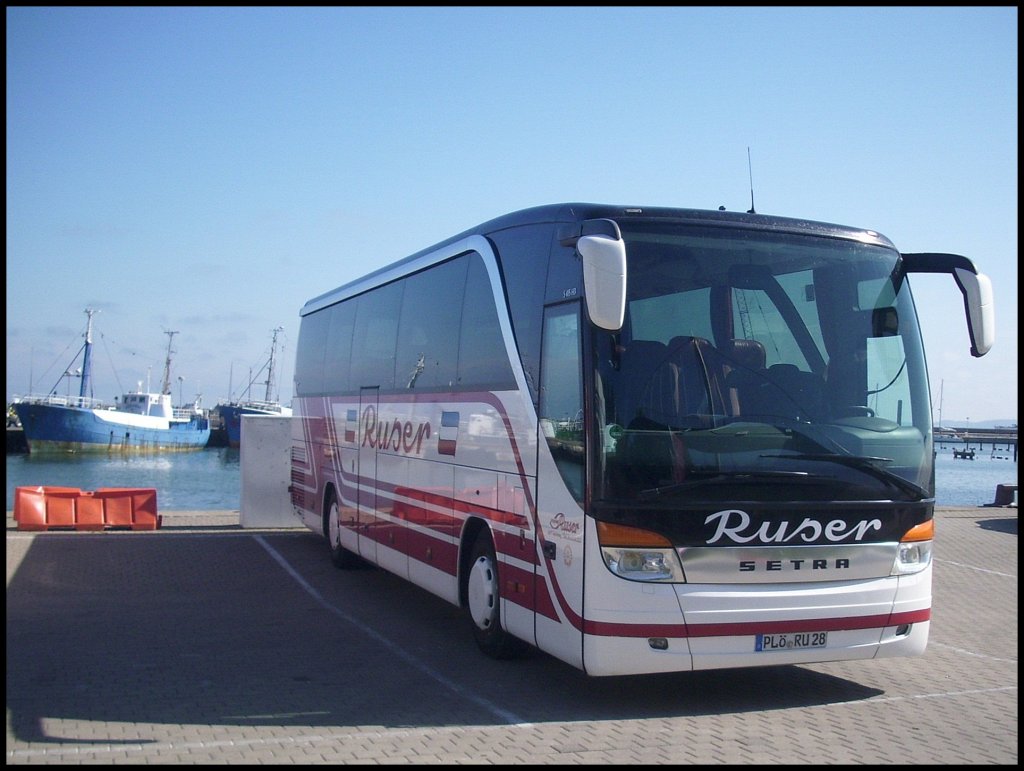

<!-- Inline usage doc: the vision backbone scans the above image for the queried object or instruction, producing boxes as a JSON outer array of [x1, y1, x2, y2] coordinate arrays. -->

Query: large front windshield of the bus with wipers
[[589, 220, 934, 501]]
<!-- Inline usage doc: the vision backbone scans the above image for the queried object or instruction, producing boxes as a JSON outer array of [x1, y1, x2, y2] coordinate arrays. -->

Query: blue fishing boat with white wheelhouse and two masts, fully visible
[[13, 308, 210, 454]]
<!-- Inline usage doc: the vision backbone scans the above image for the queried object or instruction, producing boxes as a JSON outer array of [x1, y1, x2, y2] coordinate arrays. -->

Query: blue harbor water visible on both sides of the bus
[[7, 443, 1017, 511]]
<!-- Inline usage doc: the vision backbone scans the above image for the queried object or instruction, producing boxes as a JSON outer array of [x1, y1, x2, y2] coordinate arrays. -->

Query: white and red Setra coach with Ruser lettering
[[289, 203, 994, 676]]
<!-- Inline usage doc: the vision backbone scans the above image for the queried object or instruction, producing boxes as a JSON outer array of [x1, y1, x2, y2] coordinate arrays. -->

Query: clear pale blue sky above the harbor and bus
[[6, 6, 1018, 426]]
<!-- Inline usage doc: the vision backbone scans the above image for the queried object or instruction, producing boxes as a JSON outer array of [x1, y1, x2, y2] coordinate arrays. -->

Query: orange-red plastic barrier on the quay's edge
[[14, 487, 161, 530]]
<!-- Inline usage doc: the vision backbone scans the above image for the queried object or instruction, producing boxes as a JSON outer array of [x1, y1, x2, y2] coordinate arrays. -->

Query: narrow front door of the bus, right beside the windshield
[[537, 302, 586, 667]]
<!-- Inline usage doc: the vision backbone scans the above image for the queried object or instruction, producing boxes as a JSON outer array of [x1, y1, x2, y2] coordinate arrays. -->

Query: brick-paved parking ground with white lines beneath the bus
[[7, 501, 1018, 765]]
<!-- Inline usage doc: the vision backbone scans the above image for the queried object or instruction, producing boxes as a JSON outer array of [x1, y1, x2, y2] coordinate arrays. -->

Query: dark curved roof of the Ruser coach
[[300, 203, 894, 315]]
